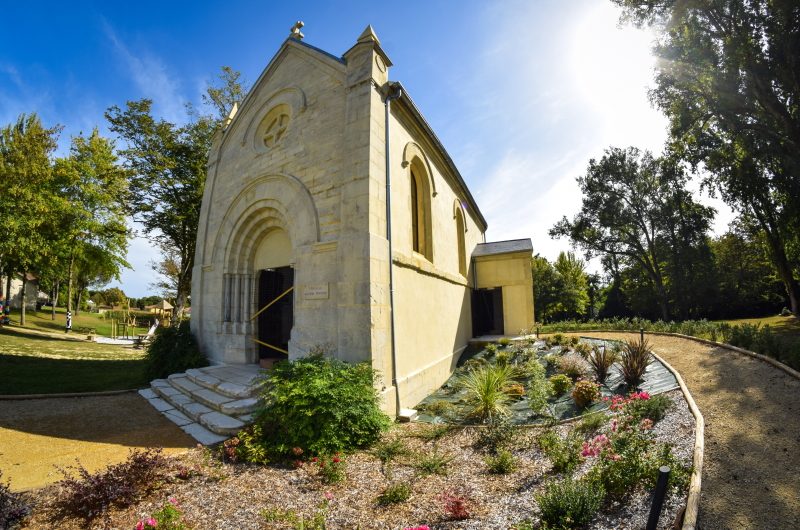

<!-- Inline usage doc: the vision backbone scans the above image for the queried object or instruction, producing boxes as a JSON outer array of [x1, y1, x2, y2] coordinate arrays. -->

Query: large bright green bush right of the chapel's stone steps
[[256, 355, 391, 456]]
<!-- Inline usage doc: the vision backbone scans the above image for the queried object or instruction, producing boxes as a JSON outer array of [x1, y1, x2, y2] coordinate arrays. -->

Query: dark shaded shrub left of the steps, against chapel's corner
[[146, 320, 208, 379]]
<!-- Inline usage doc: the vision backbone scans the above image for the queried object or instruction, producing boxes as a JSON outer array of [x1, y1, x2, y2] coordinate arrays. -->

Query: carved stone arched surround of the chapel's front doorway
[[193, 175, 319, 363]]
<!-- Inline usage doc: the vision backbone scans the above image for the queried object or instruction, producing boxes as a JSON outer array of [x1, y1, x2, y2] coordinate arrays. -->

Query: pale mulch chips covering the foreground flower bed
[[18, 390, 694, 530]]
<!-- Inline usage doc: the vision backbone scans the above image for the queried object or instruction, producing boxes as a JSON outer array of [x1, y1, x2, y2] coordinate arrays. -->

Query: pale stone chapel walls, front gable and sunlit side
[[192, 27, 533, 412]]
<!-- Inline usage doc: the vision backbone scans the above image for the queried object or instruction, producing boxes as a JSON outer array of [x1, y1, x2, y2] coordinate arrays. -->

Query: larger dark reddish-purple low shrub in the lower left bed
[[55, 449, 167, 521]]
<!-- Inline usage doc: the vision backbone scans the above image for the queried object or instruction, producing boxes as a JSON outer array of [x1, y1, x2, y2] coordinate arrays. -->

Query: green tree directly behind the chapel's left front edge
[[106, 69, 244, 320]]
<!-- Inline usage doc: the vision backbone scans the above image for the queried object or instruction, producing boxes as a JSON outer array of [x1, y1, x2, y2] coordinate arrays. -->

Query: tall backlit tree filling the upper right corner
[[613, 0, 800, 314]]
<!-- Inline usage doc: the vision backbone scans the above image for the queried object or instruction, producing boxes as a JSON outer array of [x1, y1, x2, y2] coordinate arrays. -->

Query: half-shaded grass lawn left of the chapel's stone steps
[[0, 324, 147, 394]]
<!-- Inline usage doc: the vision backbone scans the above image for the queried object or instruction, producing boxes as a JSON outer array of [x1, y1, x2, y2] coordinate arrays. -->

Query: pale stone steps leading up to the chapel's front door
[[139, 365, 260, 445]]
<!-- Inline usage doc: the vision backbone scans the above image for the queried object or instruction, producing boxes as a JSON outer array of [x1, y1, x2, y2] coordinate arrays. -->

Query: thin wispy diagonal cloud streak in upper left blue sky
[[102, 20, 186, 123]]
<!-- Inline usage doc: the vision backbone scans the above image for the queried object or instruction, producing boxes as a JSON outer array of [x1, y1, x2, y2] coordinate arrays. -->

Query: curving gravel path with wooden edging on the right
[[588, 333, 800, 529]]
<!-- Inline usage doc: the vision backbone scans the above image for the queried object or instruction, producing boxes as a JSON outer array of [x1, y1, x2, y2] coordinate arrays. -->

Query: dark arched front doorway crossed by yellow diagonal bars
[[253, 228, 294, 360]]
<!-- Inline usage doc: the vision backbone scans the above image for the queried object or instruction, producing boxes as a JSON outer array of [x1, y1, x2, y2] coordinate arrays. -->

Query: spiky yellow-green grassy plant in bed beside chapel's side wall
[[460, 365, 516, 423]]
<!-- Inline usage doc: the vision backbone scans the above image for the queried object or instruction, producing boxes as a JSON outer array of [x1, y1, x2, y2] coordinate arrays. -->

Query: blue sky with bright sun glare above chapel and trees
[[0, 0, 731, 297]]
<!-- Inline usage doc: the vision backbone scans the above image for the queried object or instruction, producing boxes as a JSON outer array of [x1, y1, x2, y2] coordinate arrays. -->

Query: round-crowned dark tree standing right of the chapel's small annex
[[550, 147, 714, 320]]
